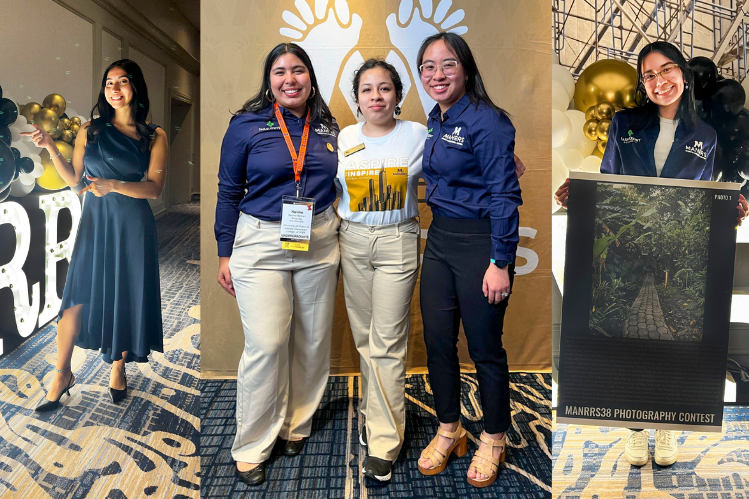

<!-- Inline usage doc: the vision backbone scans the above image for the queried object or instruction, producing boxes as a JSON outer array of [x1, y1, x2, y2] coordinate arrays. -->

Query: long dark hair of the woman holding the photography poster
[[637, 41, 698, 129]]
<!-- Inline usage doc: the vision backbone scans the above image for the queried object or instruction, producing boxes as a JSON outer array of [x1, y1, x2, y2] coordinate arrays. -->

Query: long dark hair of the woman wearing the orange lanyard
[[234, 43, 333, 127]]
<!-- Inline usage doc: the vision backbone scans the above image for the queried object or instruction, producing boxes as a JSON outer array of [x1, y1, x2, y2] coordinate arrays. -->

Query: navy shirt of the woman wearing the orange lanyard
[[214, 107, 338, 256]]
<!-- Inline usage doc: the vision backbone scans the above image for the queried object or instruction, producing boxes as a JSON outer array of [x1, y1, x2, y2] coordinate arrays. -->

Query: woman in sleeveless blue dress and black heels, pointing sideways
[[25, 59, 168, 411]]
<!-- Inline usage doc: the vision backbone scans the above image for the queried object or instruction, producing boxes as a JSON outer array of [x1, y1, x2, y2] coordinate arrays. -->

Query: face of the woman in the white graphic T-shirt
[[356, 67, 398, 126]]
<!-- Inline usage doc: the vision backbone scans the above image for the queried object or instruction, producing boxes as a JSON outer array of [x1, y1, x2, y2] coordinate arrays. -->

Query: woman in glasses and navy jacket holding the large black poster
[[555, 41, 747, 466]]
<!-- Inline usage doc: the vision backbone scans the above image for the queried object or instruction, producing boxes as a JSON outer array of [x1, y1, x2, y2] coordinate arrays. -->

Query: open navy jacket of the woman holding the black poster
[[601, 108, 717, 180]]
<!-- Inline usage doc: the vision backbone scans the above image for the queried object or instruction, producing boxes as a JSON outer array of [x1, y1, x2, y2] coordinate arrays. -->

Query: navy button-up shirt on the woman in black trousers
[[423, 94, 523, 263]]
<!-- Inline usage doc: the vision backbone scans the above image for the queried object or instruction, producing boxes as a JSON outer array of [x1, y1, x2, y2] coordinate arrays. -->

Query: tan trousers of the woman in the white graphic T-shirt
[[338, 219, 420, 461]]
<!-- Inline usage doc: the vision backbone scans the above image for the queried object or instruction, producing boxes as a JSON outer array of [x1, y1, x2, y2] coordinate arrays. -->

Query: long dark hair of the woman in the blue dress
[[86, 59, 151, 152]]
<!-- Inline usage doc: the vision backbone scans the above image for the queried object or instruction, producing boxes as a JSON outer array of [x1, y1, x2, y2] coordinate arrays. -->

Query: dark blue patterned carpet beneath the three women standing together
[[200, 374, 551, 499]]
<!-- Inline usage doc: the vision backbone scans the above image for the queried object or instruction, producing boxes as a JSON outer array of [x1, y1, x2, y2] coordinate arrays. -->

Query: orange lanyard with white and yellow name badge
[[273, 102, 315, 251]]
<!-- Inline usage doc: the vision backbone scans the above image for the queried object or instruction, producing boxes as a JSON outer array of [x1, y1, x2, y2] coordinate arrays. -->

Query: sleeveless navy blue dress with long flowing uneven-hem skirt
[[59, 124, 163, 362]]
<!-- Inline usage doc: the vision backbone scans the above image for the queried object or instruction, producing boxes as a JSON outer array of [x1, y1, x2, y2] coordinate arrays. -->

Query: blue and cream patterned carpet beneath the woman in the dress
[[0, 204, 200, 499]]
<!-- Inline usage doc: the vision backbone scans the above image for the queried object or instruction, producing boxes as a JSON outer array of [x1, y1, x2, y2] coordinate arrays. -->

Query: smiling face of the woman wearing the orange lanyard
[[270, 52, 312, 118]]
